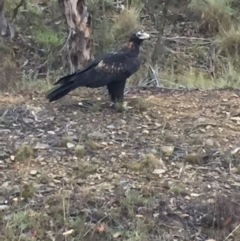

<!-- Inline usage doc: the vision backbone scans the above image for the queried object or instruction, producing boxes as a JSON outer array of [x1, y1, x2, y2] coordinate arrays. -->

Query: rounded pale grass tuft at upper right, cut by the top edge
[[188, 0, 235, 32]]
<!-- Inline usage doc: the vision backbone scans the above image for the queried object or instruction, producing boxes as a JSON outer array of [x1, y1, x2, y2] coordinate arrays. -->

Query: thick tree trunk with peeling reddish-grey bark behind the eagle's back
[[59, 0, 93, 73]]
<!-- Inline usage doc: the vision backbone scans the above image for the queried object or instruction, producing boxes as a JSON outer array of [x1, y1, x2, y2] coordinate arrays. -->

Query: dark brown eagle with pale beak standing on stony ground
[[46, 31, 150, 102]]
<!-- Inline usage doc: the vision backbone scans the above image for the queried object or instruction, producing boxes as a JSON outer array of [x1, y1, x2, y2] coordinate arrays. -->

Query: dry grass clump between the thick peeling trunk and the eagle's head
[[88, 0, 143, 55]]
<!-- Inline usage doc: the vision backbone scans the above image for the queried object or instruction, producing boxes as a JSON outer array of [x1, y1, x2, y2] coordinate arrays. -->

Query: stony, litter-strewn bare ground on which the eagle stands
[[0, 89, 240, 240]]
